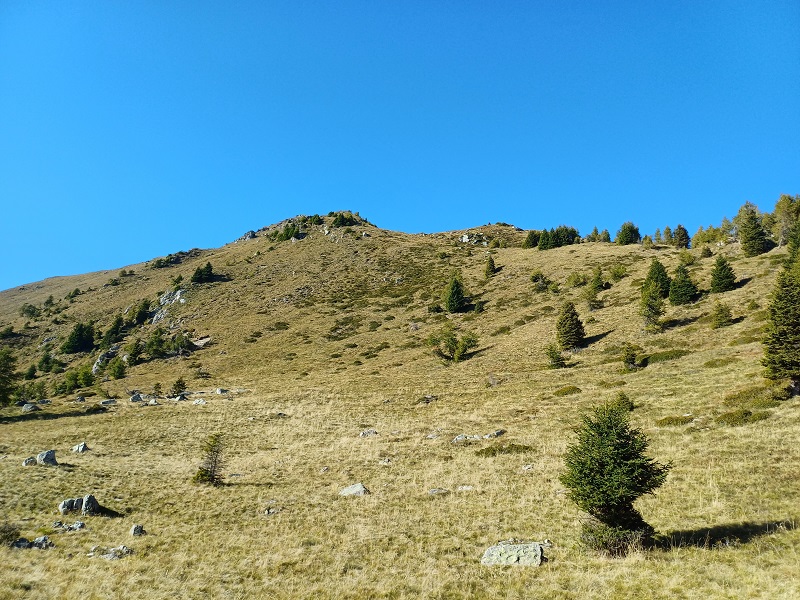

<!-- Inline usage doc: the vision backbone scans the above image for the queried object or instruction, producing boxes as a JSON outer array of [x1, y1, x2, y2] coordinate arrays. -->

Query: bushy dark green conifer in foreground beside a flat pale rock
[[559, 406, 671, 552]]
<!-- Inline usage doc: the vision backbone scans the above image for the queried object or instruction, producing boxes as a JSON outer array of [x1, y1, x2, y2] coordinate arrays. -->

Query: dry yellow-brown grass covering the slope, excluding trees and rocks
[[0, 219, 800, 598]]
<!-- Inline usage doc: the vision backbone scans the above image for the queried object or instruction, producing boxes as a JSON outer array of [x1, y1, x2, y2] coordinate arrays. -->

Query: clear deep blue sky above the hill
[[0, 0, 800, 289]]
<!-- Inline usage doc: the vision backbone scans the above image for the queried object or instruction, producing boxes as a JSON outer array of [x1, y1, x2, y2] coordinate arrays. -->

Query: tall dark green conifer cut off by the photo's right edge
[[761, 266, 800, 382]]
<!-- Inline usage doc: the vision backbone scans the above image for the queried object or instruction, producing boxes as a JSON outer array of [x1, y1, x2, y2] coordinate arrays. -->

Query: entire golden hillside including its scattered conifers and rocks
[[0, 196, 800, 600]]
